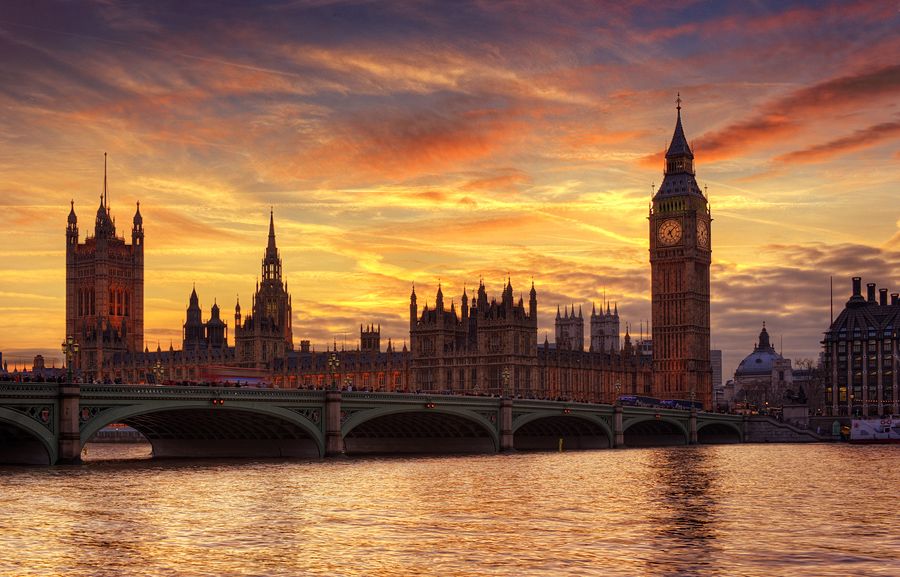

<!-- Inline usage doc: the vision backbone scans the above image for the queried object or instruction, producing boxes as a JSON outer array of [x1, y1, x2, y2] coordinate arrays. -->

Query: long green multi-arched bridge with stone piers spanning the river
[[0, 383, 749, 464]]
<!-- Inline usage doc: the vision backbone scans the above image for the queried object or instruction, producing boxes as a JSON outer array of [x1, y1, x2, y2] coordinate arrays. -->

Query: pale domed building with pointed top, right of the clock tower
[[726, 322, 793, 410]]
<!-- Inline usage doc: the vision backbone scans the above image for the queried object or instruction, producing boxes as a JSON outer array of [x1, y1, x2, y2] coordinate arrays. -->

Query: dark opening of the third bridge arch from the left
[[341, 405, 500, 454]]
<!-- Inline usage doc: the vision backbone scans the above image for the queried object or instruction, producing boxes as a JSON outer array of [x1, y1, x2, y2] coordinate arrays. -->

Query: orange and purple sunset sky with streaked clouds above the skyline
[[0, 0, 900, 379]]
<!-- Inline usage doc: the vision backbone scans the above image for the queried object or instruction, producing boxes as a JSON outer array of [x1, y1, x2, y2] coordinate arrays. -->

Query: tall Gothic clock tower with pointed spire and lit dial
[[649, 96, 712, 408]]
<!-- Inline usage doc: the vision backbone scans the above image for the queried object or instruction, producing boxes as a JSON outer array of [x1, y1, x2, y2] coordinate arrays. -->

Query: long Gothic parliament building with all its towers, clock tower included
[[66, 100, 712, 407]]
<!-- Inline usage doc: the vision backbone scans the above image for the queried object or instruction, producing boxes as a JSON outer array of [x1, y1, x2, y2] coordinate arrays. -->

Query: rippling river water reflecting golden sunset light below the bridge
[[0, 445, 900, 577]]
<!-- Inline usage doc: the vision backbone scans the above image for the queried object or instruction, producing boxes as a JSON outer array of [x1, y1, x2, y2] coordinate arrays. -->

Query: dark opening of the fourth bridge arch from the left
[[512, 410, 614, 451]]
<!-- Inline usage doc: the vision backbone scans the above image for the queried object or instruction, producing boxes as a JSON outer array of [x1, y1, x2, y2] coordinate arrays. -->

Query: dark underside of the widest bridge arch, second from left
[[81, 400, 325, 458]]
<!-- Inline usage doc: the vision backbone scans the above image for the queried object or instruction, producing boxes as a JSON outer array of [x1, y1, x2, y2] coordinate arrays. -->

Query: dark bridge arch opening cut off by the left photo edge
[[0, 407, 58, 465]]
